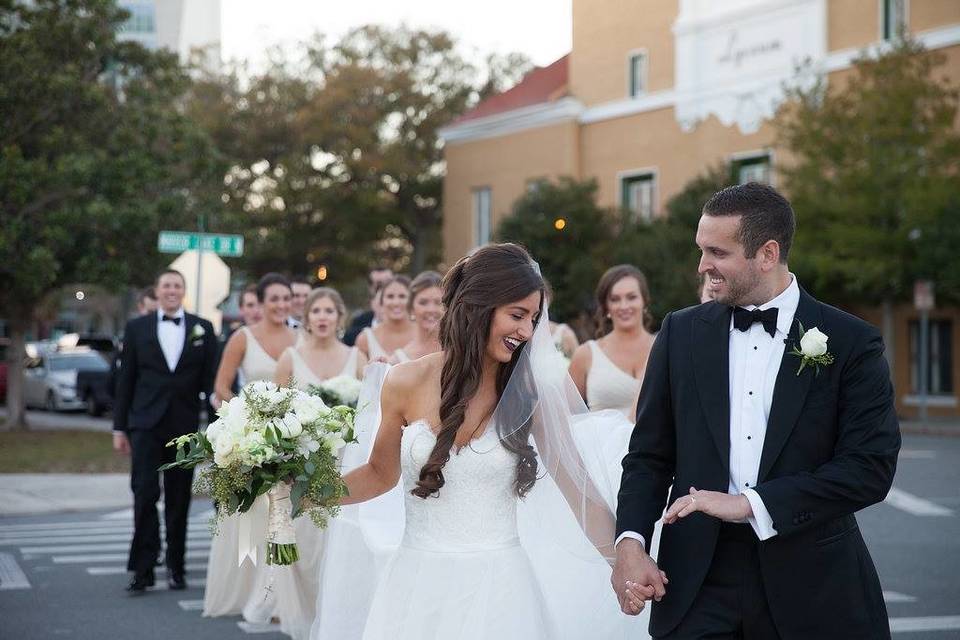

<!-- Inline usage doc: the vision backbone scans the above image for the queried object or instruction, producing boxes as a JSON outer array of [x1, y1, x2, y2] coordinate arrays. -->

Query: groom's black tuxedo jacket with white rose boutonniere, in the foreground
[[617, 290, 900, 640]]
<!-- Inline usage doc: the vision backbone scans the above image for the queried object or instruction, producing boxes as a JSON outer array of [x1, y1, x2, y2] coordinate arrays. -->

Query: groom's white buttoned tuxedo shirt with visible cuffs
[[616, 273, 800, 544]]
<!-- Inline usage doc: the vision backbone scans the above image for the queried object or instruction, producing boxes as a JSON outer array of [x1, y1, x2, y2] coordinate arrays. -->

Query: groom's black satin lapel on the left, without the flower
[[691, 303, 731, 471]]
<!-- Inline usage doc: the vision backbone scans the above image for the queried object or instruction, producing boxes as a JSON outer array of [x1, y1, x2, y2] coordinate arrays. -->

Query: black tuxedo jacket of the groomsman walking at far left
[[113, 313, 217, 435]]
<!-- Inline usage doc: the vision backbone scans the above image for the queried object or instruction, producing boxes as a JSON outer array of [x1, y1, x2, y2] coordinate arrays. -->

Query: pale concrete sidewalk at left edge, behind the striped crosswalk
[[0, 473, 133, 517]]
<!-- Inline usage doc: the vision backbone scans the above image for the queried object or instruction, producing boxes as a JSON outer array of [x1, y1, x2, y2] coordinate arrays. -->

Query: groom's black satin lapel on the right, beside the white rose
[[757, 289, 821, 482]]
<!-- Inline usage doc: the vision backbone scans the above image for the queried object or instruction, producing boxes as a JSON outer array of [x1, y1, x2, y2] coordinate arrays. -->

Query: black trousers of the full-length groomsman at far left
[[127, 423, 193, 575]]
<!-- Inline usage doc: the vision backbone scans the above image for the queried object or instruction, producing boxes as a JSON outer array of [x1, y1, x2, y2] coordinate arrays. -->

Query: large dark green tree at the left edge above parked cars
[[0, 0, 222, 428]]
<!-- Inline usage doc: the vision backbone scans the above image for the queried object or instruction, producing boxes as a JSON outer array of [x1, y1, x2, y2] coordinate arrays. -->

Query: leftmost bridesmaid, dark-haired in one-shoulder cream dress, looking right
[[203, 273, 297, 617]]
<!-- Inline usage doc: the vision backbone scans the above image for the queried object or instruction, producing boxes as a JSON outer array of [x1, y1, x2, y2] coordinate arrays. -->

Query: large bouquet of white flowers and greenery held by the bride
[[160, 382, 356, 564]]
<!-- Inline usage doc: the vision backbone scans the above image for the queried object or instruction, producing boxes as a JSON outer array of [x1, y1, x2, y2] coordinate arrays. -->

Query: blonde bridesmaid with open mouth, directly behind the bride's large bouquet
[[262, 287, 367, 640]]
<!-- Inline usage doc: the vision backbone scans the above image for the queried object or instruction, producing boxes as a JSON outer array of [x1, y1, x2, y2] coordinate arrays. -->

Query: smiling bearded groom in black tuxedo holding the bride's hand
[[611, 183, 900, 640]]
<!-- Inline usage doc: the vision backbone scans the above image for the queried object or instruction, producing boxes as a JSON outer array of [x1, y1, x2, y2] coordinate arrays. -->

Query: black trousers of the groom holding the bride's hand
[[658, 523, 780, 640]]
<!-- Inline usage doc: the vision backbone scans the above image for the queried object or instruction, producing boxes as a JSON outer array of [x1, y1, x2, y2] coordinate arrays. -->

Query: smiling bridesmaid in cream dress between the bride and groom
[[570, 264, 654, 420]]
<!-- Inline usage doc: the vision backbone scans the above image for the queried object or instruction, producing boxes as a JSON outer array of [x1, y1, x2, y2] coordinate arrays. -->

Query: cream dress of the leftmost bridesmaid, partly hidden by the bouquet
[[203, 327, 277, 617]]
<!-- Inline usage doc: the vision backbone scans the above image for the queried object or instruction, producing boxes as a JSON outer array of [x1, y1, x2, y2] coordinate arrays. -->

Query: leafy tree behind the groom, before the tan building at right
[[775, 39, 960, 334]]
